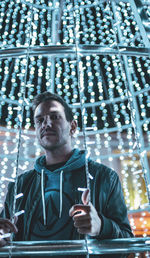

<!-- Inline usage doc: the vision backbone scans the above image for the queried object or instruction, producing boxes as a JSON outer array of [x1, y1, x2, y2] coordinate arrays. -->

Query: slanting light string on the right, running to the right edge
[[107, 0, 150, 204]]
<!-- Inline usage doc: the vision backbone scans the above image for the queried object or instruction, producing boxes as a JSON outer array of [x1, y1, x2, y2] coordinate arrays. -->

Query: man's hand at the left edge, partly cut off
[[0, 218, 18, 247]]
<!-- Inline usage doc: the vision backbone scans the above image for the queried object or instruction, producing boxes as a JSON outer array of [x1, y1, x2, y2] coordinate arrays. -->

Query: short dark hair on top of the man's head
[[32, 91, 73, 122]]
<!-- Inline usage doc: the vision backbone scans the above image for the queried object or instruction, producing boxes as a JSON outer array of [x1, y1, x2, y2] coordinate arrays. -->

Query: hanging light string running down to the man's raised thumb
[[73, 0, 91, 258]]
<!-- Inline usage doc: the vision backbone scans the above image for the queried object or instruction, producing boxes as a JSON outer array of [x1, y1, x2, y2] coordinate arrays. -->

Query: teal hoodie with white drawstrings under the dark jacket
[[30, 149, 86, 240]]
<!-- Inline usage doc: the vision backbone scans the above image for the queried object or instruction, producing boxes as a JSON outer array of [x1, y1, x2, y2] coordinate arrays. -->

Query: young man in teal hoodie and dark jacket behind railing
[[0, 92, 133, 249]]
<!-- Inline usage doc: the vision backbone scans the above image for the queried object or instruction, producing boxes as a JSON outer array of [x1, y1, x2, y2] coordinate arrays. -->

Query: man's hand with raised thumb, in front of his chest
[[69, 189, 101, 236]]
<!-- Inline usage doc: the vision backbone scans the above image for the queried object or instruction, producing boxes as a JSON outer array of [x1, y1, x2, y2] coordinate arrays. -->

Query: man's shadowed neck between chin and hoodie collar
[[45, 149, 72, 165]]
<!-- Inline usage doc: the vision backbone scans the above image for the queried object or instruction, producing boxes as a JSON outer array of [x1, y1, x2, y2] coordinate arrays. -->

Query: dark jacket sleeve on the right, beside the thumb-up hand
[[91, 167, 133, 239]]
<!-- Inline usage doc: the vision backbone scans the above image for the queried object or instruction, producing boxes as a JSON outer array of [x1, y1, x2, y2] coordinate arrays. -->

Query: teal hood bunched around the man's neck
[[34, 149, 85, 173]]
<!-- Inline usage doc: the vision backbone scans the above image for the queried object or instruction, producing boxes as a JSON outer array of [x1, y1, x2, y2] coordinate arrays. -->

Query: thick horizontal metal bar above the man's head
[[0, 44, 150, 59]]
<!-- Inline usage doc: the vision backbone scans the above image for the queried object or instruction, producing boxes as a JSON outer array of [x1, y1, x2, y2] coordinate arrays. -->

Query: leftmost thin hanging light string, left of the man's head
[[9, 0, 34, 250]]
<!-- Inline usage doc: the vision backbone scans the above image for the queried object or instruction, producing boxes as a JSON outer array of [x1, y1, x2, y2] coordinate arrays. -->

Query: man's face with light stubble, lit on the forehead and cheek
[[34, 100, 73, 150]]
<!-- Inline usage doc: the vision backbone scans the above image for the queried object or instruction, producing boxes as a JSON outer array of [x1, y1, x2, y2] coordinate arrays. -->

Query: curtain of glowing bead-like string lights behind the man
[[0, 0, 150, 241]]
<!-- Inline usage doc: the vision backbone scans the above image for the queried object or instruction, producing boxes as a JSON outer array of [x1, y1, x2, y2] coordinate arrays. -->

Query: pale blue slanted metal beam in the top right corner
[[129, 0, 150, 47]]
